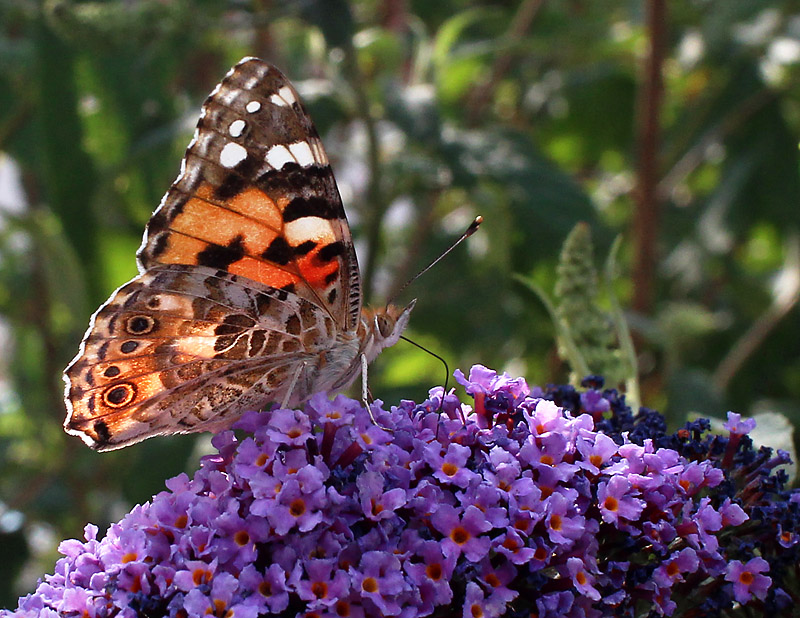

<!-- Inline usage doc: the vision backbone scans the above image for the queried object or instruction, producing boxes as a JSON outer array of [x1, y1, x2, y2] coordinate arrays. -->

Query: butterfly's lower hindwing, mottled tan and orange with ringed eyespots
[[66, 265, 336, 450]]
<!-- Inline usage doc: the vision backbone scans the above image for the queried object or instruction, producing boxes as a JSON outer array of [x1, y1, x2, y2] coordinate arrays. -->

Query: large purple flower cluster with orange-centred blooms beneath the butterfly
[[6, 366, 800, 618]]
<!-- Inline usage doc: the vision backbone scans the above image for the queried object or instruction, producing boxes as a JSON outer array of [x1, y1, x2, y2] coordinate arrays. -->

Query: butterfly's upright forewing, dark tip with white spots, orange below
[[139, 58, 361, 330]]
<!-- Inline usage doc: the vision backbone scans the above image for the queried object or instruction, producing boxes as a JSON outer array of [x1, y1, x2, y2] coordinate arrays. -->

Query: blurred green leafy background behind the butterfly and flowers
[[0, 0, 800, 606]]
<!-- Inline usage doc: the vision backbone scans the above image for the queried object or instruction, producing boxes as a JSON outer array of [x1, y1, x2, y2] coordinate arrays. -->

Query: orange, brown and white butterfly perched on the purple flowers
[[64, 58, 414, 451]]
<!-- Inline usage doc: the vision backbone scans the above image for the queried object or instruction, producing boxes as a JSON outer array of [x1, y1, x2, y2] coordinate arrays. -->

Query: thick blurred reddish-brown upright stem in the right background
[[633, 0, 667, 314]]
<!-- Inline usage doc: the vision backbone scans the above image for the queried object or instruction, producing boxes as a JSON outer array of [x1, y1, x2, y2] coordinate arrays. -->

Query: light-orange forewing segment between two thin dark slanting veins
[[170, 198, 278, 255]]
